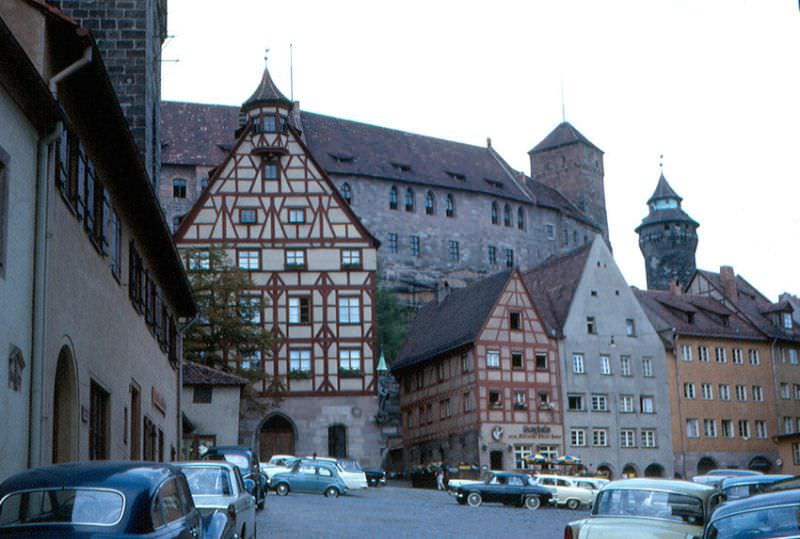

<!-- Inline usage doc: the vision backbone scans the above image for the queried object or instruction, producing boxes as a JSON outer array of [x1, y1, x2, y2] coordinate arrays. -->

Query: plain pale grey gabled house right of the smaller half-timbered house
[[525, 235, 673, 478]]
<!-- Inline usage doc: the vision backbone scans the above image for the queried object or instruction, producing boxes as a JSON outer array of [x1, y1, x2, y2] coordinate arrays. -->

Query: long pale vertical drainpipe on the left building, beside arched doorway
[[28, 122, 64, 468]]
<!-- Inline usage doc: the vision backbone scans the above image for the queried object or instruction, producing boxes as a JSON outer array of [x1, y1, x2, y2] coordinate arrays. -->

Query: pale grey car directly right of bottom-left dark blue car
[[176, 461, 256, 539]]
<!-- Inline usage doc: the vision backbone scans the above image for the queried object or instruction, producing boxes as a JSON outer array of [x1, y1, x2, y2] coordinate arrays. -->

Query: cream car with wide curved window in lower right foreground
[[564, 478, 722, 539]]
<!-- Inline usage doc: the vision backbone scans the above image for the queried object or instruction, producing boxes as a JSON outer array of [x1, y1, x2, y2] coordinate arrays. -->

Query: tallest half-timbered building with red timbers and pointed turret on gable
[[176, 62, 380, 463]]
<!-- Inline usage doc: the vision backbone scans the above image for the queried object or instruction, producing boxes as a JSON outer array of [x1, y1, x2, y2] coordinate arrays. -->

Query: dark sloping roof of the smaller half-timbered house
[[392, 270, 512, 372]]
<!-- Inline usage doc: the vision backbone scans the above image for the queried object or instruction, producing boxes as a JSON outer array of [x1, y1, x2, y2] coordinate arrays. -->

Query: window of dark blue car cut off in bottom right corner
[[707, 505, 800, 539]]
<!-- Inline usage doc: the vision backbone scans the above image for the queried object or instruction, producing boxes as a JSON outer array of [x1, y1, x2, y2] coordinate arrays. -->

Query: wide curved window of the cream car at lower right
[[593, 489, 704, 526]]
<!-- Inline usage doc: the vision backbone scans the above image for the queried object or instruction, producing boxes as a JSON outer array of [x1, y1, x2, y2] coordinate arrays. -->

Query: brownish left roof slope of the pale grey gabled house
[[523, 243, 592, 335]]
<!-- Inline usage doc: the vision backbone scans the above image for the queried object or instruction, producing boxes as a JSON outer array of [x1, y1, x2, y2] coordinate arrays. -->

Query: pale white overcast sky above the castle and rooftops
[[162, 0, 800, 301]]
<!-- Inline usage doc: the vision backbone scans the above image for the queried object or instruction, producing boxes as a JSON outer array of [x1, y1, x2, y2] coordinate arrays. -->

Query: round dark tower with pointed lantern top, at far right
[[636, 173, 700, 290]]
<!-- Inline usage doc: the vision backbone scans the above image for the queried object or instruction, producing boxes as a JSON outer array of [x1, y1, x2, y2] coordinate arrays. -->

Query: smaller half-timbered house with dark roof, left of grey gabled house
[[392, 270, 564, 470]]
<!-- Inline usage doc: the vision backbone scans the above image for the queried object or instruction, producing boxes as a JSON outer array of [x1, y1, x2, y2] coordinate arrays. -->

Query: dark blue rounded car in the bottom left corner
[[0, 461, 203, 539]]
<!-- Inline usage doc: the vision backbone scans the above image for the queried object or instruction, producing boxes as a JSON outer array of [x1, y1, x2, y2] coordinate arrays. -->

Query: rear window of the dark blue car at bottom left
[[0, 488, 125, 535]]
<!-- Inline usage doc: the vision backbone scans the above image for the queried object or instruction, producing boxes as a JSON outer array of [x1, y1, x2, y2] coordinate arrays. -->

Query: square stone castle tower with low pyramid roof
[[528, 122, 608, 240]]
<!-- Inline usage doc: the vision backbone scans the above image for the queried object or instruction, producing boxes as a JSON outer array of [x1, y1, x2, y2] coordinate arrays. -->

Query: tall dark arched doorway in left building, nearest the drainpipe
[[52, 346, 78, 463]]
